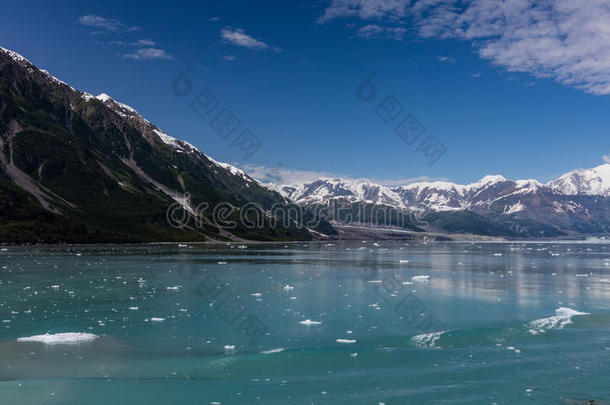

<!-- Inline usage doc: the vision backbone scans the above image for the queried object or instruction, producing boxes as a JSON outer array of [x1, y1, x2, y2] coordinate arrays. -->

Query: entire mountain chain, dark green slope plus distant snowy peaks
[[0, 47, 610, 243]]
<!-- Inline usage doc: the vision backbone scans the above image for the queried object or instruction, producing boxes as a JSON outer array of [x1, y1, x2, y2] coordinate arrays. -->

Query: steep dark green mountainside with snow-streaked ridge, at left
[[0, 48, 330, 243]]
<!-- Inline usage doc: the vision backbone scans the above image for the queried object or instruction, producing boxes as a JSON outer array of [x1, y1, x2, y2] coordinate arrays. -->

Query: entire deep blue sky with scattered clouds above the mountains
[[0, 0, 610, 184]]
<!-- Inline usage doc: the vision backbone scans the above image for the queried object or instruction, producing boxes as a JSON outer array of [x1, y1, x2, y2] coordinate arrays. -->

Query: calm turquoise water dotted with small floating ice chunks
[[0, 242, 610, 405]]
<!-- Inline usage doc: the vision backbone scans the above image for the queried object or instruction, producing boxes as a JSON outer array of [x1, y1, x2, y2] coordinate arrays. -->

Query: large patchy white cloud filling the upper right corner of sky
[[318, 0, 610, 95]]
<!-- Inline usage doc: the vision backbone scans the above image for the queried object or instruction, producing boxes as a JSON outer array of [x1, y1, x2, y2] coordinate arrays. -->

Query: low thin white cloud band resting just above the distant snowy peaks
[[243, 165, 446, 186]]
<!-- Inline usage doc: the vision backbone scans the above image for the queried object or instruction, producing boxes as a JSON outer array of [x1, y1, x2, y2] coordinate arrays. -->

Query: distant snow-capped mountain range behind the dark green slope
[[276, 164, 610, 237]]
